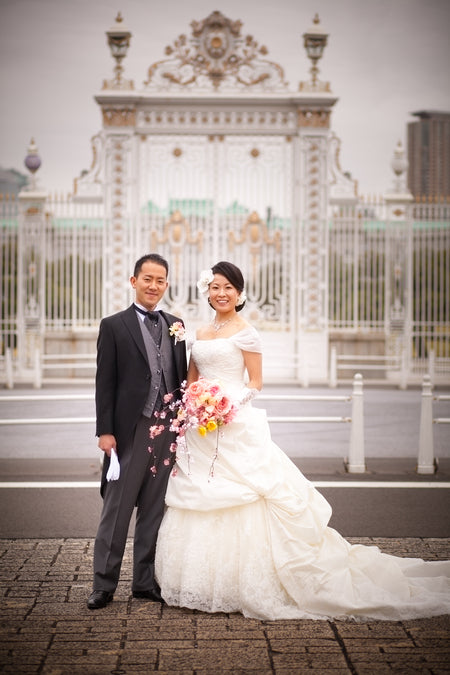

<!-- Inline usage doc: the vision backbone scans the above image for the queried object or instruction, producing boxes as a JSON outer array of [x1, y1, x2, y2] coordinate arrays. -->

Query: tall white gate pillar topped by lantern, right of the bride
[[294, 16, 337, 386]]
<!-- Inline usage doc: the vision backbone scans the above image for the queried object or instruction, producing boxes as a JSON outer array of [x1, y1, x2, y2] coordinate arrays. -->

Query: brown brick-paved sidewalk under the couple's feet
[[0, 538, 450, 675]]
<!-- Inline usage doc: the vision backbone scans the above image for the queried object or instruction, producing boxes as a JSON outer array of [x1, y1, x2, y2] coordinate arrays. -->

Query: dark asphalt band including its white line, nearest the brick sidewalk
[[0, 459, 450, 540]]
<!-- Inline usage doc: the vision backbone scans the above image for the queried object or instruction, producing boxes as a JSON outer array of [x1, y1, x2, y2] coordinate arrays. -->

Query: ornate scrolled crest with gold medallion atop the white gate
[[144, 11, 287, 91]]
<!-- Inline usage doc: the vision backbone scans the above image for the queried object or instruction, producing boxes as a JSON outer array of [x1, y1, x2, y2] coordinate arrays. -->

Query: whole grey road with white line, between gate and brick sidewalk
[[0, 387, 450, 538]]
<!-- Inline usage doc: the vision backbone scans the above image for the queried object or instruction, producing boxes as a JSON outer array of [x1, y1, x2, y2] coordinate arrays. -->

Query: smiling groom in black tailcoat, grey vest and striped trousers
[[87, 253, 186, 609]]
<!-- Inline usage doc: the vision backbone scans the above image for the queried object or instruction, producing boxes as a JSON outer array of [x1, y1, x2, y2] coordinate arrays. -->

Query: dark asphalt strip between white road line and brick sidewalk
[[0, 488, 450, 540]]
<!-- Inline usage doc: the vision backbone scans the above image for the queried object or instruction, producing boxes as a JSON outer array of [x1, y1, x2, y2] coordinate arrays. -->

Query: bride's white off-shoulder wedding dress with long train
[[155, 328, 450, 621]]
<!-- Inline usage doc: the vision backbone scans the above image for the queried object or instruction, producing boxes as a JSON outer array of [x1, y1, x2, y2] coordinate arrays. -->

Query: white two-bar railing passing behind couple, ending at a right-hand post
[[0, 373, 366, 473]]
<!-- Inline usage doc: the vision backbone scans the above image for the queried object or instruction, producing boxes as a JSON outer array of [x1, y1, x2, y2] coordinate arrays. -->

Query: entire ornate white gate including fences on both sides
[[0, 12, 450, 384]]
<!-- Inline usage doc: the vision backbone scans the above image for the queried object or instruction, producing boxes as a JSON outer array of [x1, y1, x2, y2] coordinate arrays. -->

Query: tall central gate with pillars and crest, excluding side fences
[[78, 12, 342, 381]]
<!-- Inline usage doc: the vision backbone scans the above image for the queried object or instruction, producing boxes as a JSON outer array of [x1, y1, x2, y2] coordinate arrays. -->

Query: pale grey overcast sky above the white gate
[[0, 0, 450, 194]]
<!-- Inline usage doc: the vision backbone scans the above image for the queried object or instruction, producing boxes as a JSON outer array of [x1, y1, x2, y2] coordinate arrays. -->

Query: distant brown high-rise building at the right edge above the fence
[[408, 110, 450, 199]]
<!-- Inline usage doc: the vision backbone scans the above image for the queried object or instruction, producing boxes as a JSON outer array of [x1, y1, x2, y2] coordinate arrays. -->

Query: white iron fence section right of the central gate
[[328, 199, 450, 373]]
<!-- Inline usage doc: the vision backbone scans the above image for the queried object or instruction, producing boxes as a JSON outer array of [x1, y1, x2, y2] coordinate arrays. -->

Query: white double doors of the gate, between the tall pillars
[[137, 136, 293, 312]]
